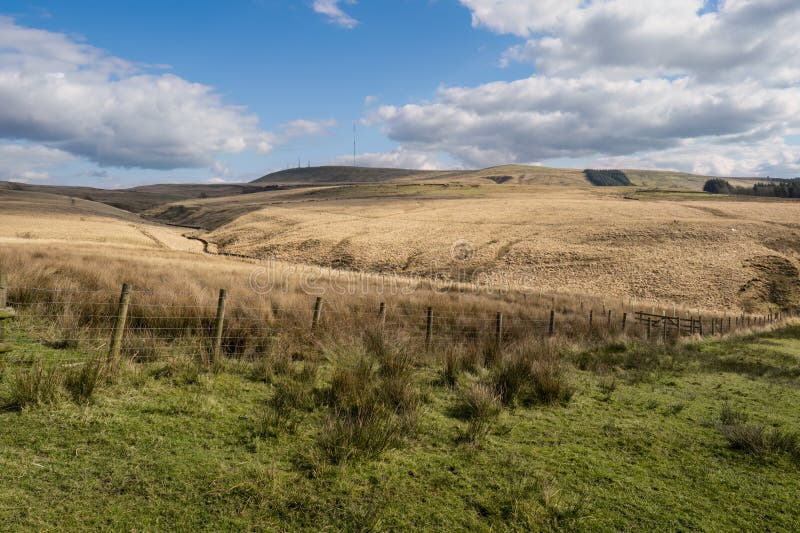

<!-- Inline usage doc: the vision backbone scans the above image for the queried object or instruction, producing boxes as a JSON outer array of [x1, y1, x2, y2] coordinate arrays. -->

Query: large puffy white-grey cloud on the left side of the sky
[[0, 17, 332, 169]]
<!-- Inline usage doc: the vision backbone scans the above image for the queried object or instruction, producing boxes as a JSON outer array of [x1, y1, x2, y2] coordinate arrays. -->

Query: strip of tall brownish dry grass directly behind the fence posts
[[0, 242, 624, 368]]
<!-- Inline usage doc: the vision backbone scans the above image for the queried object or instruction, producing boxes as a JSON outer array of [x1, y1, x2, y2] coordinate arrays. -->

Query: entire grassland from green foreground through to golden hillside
[[0, 167, 800, 531]]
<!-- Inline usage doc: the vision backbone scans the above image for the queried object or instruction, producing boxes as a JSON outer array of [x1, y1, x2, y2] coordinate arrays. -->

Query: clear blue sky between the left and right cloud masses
[[3, 0, 530, 185]]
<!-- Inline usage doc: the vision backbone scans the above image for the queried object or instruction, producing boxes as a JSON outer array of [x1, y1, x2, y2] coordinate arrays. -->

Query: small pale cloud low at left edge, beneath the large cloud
[[0, 142, 75, 182]]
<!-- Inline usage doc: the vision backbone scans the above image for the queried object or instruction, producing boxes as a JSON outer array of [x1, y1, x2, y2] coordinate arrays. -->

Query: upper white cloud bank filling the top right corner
[[478, 0, 800, 86]]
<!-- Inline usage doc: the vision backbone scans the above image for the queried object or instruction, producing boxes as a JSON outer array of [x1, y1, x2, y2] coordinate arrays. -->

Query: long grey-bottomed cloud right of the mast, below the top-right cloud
[[377, 76, 800, 166]]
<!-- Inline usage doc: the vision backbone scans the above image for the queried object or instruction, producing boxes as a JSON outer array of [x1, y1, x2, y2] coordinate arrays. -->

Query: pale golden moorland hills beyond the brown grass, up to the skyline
[[0, 165, 800, 313]]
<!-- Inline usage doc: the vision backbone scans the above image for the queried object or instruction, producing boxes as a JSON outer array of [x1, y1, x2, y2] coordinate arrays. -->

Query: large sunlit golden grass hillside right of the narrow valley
[[153, 184, 800, 310]]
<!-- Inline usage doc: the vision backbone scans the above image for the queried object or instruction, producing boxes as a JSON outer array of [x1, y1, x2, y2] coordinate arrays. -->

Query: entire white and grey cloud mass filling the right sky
[[370, 0, 800, 175]]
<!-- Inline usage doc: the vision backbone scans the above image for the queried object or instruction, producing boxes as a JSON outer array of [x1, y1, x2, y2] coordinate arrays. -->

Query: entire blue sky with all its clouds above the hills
[[0, 0, 800, 188]]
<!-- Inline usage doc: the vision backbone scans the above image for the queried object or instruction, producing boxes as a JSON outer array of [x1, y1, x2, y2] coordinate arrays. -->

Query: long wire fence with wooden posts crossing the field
[[0, 277, 786, 364]]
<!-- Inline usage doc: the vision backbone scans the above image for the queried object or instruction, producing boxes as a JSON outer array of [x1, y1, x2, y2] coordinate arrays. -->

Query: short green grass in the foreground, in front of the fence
[[0, 326, 800, 531]]
